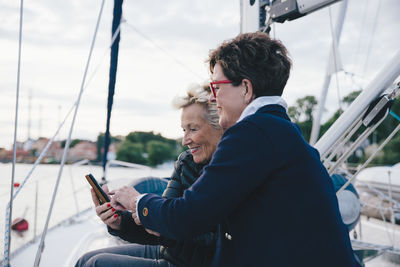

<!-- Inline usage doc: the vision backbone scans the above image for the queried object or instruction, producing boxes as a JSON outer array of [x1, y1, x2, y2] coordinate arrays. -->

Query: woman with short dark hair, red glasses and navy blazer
[[117, 32, 356, 267]]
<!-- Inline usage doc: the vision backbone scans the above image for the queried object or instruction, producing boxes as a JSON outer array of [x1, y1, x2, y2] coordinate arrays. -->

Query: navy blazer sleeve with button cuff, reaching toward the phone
[[138, 120, 279, 240]]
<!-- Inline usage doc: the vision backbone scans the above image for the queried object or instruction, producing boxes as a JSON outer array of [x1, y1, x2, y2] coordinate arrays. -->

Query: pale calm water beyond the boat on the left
[[0, 163, 173, 259]]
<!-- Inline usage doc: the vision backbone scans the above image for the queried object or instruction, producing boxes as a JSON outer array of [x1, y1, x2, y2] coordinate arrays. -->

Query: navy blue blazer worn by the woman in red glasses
[[138, 105, 355, 267]]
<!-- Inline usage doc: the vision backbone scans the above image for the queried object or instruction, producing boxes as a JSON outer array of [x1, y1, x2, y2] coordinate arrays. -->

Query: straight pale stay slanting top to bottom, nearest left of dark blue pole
[[34, 0, 105, 267]]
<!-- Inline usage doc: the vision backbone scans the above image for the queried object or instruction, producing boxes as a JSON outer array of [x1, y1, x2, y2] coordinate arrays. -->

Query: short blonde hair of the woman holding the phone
[[172, 83, 221, 130]]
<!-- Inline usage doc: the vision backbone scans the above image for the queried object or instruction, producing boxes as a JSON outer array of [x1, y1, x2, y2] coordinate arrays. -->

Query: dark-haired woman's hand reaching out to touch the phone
[[110, 186, 140, 212]]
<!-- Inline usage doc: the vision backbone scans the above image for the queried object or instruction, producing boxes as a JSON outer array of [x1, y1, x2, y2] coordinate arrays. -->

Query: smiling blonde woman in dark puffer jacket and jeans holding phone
[[76, 85, 222, 267]]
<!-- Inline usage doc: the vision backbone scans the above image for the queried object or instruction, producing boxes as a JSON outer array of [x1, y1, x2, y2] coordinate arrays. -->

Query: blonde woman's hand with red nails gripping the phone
[[90, 185, 121, 230]]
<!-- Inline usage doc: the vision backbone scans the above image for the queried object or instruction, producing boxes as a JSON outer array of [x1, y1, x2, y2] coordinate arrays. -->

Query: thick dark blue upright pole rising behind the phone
[[102, 0, 123, 183]]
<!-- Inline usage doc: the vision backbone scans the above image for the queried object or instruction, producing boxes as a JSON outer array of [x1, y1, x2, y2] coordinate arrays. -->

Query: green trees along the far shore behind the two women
[[97, 91, 400, 166]]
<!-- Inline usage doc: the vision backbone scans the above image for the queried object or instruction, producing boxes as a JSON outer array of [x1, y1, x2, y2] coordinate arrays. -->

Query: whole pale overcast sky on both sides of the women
[[0, 0, 400, 148]]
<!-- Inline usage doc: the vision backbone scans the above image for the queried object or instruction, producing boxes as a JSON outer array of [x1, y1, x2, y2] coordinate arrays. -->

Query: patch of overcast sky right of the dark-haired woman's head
[[276, 0, 400, 111]]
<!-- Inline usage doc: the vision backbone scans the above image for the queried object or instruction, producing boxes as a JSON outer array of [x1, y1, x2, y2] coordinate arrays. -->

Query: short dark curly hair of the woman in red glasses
[[208, 32, 292, 98]]
